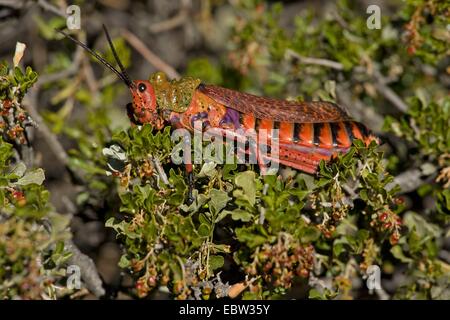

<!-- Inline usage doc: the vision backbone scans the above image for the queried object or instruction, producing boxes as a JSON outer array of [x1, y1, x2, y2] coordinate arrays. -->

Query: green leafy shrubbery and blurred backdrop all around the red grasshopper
[[0, 0, 450, 299]]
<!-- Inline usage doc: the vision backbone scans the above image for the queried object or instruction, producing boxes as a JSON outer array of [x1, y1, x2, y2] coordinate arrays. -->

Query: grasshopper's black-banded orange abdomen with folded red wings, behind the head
[[163, 85, 376, 173]]
